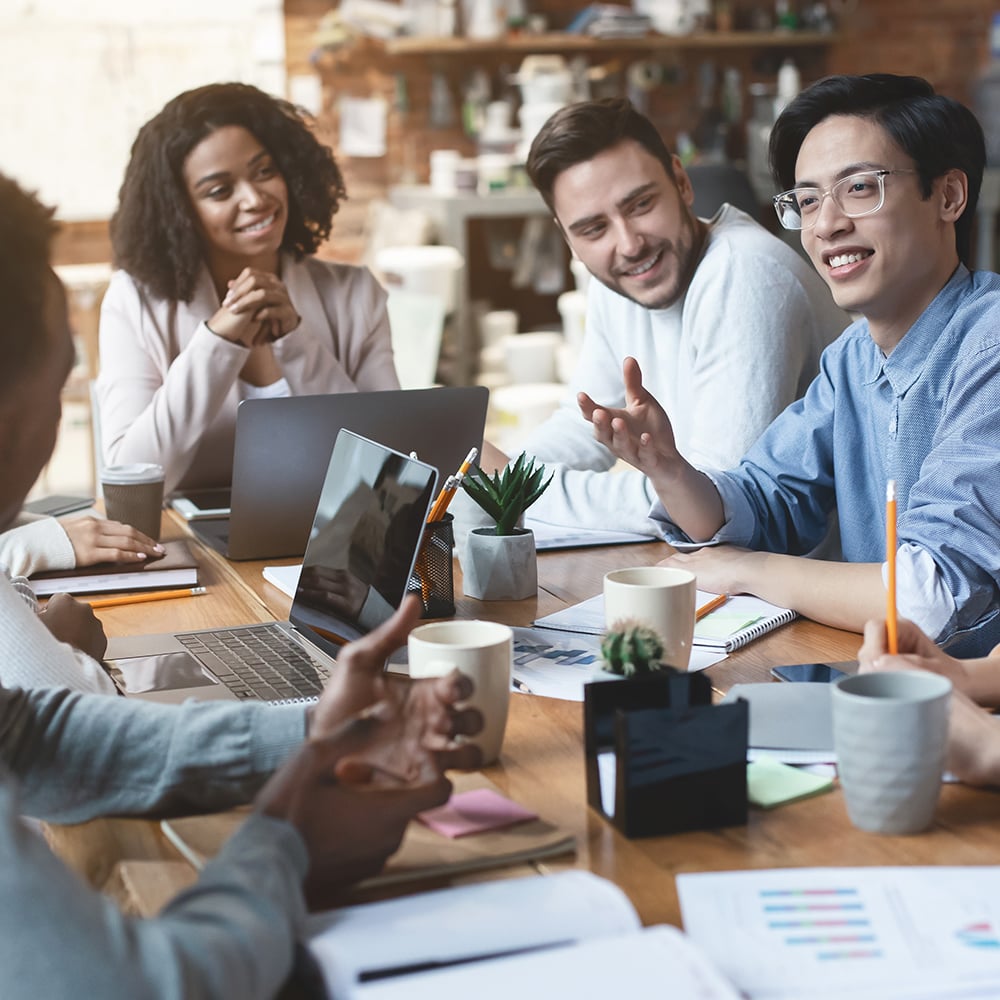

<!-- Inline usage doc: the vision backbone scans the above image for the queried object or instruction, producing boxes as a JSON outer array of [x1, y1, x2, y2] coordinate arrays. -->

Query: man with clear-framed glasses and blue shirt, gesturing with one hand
[[581, 74, 1000, 655]]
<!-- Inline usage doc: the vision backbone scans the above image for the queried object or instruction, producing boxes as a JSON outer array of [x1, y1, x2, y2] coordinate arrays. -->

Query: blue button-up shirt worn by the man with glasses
[[653, 266, 1000, 656]]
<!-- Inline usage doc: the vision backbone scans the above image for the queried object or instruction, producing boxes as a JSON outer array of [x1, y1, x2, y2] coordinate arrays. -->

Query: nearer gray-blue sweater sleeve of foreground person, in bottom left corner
[[0, 780, 307, 1000]]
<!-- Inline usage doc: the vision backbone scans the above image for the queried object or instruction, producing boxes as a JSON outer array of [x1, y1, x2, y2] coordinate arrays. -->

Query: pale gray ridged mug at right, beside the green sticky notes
[[831, 670, 951, 834]]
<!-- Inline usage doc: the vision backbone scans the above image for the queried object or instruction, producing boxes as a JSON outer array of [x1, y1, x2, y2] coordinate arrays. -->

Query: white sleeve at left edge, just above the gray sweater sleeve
[[0, 573, 118, 695]]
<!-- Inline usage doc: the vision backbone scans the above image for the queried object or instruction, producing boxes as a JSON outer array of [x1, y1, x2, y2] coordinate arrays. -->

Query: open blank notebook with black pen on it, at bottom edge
[[308, 871, 738, 1000]]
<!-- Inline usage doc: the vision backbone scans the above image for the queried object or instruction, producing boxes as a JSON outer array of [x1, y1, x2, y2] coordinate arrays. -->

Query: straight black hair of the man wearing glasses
[[768, 73, 986, 264]]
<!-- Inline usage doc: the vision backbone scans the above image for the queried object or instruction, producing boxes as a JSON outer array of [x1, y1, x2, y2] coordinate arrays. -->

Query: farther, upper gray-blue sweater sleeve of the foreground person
[[0, 688, 305, 823]]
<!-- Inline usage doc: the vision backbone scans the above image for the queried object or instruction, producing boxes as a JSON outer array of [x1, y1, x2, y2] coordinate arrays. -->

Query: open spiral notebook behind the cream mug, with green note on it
[[535, 590, 798, 653]]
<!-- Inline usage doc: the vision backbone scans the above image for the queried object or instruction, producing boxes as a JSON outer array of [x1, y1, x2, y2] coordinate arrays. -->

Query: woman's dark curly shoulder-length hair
[[111, 83, 347, 302]]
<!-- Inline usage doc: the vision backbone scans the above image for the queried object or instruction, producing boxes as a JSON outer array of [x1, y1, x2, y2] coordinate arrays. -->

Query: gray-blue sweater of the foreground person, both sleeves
[[0, 689, 308, 1000]]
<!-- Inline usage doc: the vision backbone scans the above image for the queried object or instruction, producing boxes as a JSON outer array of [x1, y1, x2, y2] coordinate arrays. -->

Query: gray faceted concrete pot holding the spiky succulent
[[459, 528, 538, 601]]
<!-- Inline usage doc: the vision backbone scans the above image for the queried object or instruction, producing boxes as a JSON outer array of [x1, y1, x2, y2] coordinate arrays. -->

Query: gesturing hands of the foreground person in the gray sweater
[[255, 597, 483, 909]]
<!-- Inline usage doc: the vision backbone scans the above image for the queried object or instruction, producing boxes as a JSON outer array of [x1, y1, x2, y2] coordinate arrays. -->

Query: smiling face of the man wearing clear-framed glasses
[[795, 115, 965, 352]]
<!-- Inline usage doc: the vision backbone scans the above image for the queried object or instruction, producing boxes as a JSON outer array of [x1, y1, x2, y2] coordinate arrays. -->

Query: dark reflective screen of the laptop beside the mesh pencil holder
[[289, 430, 437, 656]]
